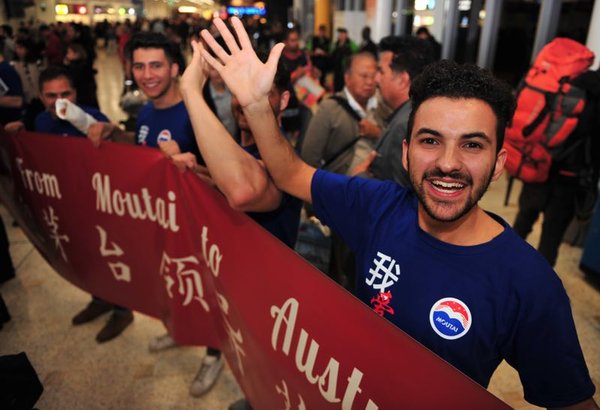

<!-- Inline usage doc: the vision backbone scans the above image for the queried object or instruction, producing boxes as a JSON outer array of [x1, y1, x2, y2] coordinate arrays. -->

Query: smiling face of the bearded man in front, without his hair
[[403, 97, 506, 223]]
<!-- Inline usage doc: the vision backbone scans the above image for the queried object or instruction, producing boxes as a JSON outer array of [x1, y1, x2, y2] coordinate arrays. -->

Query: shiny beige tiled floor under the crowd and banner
[[0, 47, 600, 410]]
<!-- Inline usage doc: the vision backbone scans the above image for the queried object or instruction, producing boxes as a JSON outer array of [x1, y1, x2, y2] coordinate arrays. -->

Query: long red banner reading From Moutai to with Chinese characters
[[0, 133, 506, 410]]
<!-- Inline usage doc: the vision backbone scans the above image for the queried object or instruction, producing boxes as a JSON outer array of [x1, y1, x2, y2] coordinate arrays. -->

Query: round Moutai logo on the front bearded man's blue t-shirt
[[429, 298, 473, 340]]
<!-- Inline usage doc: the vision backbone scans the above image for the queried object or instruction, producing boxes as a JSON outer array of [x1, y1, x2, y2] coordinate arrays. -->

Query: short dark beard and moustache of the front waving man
[[406, 153, 495, 222]]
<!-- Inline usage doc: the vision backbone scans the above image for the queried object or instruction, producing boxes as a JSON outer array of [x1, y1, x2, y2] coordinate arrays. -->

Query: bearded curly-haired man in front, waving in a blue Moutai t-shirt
[[202, 18, 598, 409]]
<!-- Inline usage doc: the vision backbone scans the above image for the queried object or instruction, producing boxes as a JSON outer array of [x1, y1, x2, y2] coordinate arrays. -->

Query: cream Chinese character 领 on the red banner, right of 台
[[160, 252, 210, 312]]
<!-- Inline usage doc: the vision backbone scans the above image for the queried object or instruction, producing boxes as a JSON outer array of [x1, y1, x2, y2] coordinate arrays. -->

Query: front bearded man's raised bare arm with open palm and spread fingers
[[201, 17, 315, 202]]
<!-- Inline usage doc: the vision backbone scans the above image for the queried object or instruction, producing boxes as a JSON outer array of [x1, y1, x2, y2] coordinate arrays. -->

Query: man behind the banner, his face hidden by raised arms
[[146, 36, 302, 397]]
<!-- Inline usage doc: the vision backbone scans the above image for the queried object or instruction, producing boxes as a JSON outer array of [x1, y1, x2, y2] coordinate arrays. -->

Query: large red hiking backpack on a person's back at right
[[504, 38, 594, 182]]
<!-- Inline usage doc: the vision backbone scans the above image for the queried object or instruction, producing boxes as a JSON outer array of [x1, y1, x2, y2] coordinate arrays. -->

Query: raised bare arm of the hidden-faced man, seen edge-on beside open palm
[[180, 36, 282, 212]]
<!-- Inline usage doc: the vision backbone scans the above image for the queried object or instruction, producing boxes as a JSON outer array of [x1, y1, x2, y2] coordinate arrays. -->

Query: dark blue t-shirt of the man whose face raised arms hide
[[242, 144, 302, 248]]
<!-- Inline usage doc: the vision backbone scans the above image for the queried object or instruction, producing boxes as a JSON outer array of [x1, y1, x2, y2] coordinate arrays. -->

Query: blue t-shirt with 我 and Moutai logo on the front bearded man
[[312, 170, 595, 407]]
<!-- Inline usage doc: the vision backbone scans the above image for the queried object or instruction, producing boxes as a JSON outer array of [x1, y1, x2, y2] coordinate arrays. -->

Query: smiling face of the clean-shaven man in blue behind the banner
[[131, 48, 179, 107]]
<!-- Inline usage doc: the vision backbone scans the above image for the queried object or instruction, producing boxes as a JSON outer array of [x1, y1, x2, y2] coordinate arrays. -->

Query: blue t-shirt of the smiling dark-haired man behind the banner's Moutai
[[135, 101, 204, 164]]
